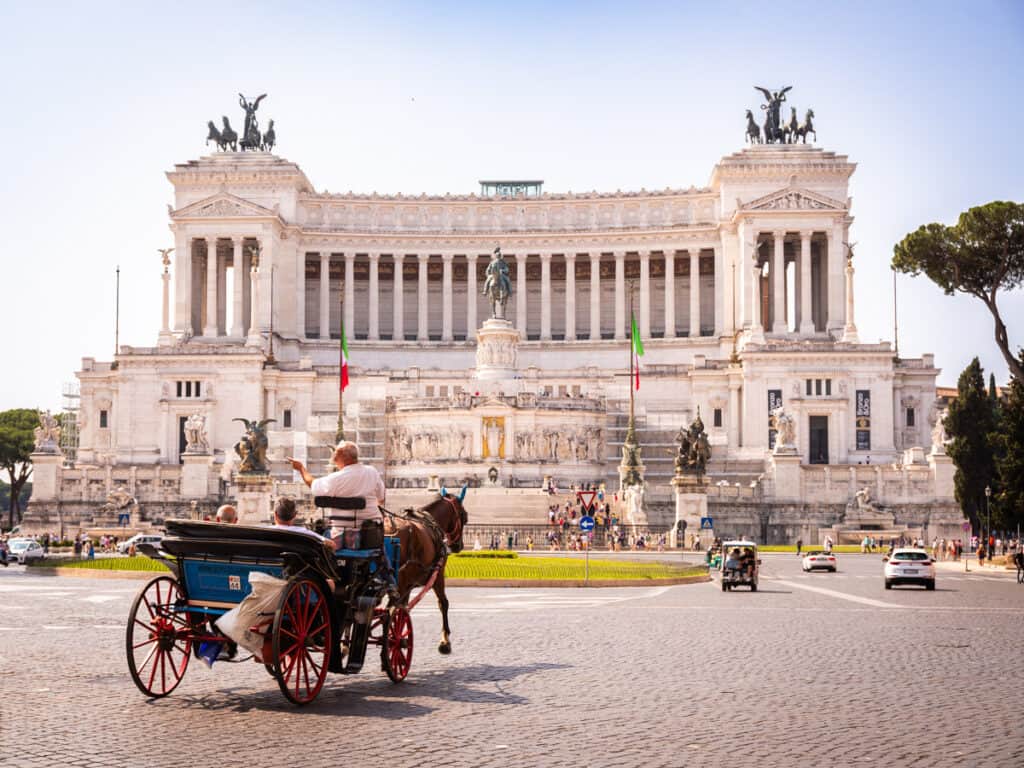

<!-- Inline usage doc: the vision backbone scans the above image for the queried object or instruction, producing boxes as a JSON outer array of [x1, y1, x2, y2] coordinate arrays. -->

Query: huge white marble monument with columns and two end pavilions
[[33, 93, 959, 541]]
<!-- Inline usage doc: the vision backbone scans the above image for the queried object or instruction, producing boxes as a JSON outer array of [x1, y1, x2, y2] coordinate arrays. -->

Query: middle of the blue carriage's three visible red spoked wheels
[[272, 579, 332, 706]]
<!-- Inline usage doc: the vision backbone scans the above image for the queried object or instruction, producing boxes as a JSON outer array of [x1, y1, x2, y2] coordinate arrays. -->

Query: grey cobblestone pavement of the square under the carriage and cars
[[0, 555, 1024, 768]]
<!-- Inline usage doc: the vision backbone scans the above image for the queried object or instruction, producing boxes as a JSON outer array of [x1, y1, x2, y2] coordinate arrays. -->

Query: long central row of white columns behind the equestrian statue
[[296, 248, 722, 341]]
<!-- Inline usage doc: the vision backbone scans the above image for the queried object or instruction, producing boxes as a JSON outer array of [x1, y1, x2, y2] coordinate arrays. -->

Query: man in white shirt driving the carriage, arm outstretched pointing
[[289, 440, 384, 547]]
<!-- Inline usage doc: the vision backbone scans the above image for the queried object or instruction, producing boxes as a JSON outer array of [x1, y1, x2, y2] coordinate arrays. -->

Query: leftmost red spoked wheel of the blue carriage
[[125, 577, 193, 698]]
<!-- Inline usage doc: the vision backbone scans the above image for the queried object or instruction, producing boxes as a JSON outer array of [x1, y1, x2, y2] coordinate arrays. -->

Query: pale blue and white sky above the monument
[[0, 0, 1024, 410]]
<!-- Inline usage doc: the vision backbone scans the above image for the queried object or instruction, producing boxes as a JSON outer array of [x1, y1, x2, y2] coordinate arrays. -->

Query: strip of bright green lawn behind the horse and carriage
[[32, 555, 707, 581]]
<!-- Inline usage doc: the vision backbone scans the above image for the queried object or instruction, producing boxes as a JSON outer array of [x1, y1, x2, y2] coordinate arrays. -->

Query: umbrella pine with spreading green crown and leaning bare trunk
[[892, 201, 1024, 379]]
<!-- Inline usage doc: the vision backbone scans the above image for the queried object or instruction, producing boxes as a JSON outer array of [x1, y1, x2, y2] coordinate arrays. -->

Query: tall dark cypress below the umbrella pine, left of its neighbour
[[945, 357, 995, 527]]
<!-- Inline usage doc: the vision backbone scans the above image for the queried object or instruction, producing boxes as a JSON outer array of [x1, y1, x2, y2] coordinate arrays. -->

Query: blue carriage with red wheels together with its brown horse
[[125, 497, 465, 705]]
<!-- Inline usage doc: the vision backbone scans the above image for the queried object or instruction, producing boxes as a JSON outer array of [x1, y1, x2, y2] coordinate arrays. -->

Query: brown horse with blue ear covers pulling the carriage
[[384, 487, 468, 653]]
